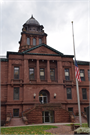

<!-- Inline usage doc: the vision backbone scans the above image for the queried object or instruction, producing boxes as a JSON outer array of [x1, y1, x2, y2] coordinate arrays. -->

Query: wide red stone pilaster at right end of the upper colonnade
[[57, 60, 63, 83]]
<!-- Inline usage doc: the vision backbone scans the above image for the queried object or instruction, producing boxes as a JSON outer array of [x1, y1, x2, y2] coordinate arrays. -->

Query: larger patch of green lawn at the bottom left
[[1, 125, 57, 135]]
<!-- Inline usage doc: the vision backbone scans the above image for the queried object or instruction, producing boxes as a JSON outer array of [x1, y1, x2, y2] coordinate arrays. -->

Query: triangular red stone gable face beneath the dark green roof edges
[[28, 46, 57, 54]]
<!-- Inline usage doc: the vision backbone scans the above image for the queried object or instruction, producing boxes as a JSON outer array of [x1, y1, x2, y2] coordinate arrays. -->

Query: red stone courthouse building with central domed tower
[[1, 16, 90, 123]]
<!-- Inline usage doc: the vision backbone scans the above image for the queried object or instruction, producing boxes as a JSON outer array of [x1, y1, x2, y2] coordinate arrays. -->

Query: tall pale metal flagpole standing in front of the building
[[71, 21, 82, 126]]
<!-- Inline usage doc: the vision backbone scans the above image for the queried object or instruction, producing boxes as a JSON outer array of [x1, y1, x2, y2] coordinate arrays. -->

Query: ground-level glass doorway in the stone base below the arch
[[42, 111, 54, 123]]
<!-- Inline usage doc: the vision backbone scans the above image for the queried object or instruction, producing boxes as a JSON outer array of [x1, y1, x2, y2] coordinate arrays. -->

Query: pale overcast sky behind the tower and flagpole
[[0, 0, 90, 61]]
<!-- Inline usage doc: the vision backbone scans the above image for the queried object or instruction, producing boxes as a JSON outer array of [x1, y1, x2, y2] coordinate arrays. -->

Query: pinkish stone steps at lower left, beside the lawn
[[8, 118, 25, 126]]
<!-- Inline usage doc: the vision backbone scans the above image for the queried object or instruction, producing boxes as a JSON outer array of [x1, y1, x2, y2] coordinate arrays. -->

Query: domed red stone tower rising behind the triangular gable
[[19, 15, 47, 52]]
